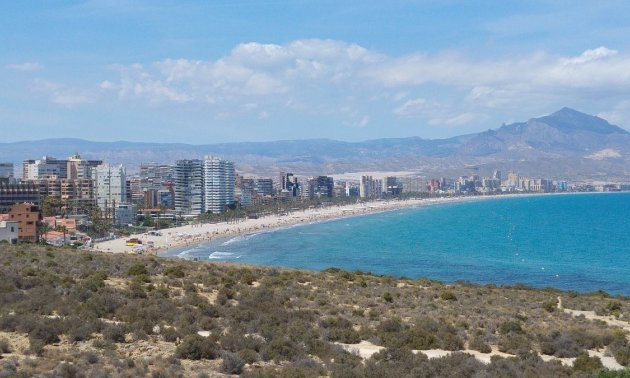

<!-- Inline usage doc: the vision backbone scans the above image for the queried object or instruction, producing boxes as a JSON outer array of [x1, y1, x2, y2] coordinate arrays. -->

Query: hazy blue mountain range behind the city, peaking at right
[[0, 108, 630, 180]]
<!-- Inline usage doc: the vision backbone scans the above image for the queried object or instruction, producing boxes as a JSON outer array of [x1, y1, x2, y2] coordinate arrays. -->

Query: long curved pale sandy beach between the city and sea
[[92, 193, 580, 257]]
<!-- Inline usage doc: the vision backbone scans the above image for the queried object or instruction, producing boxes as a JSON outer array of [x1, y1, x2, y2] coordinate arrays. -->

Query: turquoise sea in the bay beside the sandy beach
[[168, 193, 630, 295]]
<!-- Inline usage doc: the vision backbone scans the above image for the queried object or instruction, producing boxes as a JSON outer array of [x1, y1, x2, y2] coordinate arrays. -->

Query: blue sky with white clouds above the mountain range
[[0, 0, 630, 144]]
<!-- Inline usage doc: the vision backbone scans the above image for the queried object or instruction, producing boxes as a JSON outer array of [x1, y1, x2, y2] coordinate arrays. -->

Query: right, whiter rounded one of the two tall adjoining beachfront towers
[[203, 156, 234, 213]]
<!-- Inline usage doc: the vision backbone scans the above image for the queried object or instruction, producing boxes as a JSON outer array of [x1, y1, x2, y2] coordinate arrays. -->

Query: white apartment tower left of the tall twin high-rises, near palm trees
[[92, 164, 127, 212]]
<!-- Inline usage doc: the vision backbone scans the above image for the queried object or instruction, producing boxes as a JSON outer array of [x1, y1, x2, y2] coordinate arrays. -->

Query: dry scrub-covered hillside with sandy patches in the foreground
[[0, 244, 630, 377]]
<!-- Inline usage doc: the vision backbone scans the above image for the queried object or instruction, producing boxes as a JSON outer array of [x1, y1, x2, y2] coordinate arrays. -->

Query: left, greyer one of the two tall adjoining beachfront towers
[[175, 159, 205, 215]]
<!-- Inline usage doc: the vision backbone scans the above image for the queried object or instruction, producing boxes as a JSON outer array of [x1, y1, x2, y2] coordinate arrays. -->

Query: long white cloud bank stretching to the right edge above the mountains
[[92, 39, 630, 127]]
